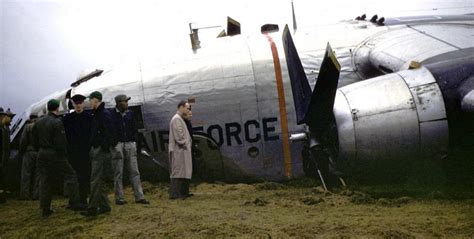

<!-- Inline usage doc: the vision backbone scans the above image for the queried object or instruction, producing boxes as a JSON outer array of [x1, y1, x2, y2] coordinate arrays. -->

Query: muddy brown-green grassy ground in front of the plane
[[0, 178, 474, 238]]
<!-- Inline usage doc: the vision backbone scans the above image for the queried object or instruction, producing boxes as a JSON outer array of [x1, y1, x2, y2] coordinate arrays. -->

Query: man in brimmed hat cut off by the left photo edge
[[0, 107, 15, 203]]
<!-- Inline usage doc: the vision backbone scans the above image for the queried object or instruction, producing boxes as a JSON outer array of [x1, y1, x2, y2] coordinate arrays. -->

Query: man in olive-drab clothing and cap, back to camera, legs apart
[[33, 99, 80, 217]]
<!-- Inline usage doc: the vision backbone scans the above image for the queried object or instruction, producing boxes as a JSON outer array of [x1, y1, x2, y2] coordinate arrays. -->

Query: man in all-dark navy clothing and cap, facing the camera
[[63, 94, 92, 205]]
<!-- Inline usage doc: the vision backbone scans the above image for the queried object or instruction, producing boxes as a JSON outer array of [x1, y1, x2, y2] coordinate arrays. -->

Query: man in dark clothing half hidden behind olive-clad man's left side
[[18, 114, 39, 200]]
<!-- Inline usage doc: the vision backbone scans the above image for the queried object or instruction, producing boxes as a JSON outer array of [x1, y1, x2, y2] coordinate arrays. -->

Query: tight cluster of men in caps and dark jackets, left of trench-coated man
[[21, 91, 149, 217]]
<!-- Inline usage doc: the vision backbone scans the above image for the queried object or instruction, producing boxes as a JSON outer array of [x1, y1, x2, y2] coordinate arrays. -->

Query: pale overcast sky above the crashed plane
[[0, 0, 474, 113]]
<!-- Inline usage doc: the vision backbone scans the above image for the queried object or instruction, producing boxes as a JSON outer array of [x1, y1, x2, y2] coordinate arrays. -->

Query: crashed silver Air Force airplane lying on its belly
[[6, 11, 474, 187]]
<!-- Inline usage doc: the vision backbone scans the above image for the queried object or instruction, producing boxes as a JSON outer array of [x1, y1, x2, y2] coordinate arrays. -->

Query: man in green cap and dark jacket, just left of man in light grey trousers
[[81, 91, 112, 216]]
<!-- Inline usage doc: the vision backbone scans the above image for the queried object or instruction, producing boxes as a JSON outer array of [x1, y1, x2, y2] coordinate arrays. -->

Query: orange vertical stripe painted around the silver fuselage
[[266, 35, 291, 178]]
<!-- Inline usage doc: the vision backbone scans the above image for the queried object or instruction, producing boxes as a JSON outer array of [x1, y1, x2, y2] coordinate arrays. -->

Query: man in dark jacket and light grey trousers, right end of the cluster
[[111, 95, 150, 205]]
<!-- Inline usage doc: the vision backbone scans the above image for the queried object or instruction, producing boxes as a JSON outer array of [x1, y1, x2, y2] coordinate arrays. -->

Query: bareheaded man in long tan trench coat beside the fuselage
[[168, 101, 193, 199]]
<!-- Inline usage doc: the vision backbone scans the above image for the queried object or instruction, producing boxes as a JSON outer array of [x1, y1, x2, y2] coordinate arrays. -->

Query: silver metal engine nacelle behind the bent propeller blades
[[333, 67, 449, 160]]
